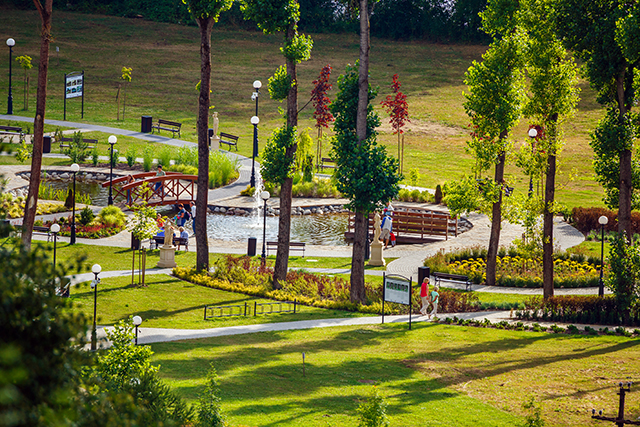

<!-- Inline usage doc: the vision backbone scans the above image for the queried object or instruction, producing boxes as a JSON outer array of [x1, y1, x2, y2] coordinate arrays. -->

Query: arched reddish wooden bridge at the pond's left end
[[101, 172, 198, 206]]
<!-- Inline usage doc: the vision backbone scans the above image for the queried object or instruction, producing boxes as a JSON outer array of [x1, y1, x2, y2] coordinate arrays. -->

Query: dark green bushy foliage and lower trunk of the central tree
[[331, 65, 401, 303]]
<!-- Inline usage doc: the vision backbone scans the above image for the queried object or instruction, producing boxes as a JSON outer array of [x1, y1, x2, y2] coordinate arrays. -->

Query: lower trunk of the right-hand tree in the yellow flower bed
[[542, 153, 556, 299]]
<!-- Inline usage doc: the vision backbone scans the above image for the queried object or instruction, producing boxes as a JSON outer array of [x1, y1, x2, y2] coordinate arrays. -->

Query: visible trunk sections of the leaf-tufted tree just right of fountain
[[273, 23, 298, 289]]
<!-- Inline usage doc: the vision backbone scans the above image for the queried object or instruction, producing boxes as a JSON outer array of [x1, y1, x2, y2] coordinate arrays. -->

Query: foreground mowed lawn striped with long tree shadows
[[152, 323, 640, 427]]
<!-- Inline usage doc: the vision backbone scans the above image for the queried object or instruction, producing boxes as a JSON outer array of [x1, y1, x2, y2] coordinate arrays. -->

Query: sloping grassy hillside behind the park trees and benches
[[0, 10, 603, 207]]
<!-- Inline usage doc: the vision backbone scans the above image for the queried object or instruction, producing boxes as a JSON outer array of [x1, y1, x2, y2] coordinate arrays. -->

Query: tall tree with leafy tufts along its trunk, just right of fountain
[[242, 0, 313, 289]]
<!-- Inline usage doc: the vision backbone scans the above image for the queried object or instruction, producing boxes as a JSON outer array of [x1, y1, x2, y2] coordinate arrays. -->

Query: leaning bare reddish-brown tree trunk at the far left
[[22, 0, 53, 250]]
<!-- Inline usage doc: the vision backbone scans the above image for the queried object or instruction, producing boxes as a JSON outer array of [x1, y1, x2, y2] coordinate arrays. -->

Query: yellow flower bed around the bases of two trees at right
[[425, 251, 599, 288]]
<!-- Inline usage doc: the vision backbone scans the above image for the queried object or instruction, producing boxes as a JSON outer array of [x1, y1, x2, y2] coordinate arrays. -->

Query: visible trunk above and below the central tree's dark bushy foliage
[[350, 0, 369, 304]]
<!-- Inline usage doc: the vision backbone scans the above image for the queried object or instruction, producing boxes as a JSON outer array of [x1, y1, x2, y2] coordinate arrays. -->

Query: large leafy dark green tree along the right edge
[[554, 0, 640, 241]]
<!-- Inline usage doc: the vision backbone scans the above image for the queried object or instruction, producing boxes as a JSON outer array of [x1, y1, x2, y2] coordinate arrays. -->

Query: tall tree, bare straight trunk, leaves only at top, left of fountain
[[182, 0, 233, 270]]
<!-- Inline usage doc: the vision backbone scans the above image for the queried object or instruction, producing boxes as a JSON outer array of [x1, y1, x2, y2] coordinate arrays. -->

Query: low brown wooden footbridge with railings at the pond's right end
[[344, 206, 458, 244]]
